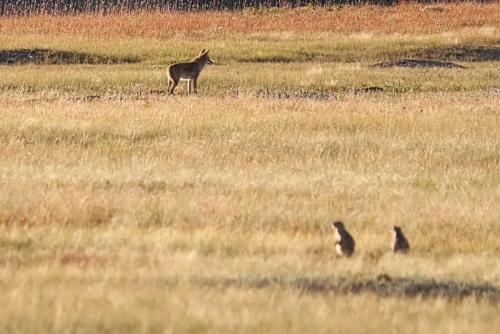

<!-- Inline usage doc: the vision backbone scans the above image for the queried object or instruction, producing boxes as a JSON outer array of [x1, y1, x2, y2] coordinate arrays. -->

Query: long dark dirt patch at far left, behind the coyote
[[0, 49, 138, 65]]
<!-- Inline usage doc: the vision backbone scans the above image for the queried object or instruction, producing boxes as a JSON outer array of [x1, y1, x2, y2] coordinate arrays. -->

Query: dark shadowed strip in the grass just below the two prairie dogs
[[193, 275, 500, 303]]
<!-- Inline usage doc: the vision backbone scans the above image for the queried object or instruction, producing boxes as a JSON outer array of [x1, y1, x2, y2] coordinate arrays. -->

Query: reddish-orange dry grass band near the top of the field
[[0, 4, 500, 38]]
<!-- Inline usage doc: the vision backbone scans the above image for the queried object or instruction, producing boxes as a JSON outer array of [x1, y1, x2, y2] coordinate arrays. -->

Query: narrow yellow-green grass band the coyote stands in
[[0, 59, 500, 94]]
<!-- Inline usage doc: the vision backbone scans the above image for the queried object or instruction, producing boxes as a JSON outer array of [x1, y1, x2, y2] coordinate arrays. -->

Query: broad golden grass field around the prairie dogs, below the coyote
[[0, 92, 500, 333]]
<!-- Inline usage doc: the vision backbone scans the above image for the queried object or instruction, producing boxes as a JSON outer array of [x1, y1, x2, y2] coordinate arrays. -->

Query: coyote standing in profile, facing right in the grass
[[167, 49, 214, 94]]
